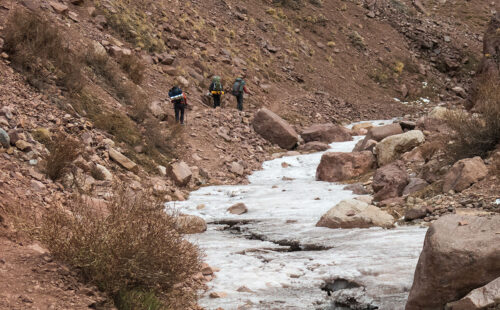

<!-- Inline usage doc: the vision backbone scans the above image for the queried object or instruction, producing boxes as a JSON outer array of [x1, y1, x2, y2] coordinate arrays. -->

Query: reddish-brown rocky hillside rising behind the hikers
[[0, 0, 500, 308]]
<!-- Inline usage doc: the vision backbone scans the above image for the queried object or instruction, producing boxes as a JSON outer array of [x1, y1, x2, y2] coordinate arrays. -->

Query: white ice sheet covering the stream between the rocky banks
[[168, 121, 426, 310]]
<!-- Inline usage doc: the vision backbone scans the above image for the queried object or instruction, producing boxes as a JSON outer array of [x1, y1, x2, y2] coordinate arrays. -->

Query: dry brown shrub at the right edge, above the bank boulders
[[447, 78, 500, 160]]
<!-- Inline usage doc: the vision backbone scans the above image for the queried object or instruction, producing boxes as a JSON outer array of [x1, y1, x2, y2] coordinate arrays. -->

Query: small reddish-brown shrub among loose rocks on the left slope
[[45, 132, 81, 180]]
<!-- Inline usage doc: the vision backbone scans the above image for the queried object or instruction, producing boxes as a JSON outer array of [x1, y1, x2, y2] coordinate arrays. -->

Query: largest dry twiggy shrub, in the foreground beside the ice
[[40, 189, 201, 309]]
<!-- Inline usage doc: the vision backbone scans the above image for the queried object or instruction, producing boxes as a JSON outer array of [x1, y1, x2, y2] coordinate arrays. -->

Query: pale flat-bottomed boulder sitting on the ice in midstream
[[316, 199, 394, 228]]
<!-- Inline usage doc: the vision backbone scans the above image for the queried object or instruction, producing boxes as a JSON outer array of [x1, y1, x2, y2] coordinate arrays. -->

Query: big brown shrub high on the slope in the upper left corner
[[4, 10, 85, 92]]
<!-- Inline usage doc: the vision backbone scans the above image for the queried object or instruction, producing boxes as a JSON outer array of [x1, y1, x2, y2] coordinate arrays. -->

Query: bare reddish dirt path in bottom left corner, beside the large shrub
[[0, 238, 108, 309]]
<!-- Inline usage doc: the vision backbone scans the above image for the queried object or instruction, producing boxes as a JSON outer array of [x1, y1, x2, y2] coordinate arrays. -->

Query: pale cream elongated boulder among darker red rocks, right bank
[[374, 130, 425, 167]]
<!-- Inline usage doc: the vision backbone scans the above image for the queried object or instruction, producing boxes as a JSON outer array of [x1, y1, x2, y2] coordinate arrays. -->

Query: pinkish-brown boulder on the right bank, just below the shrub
[[443, 157, 488, 193]]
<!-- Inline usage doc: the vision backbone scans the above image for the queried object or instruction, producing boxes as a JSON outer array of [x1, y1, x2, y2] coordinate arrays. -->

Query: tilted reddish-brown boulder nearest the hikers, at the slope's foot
[[253, 109, 299, 149]]
